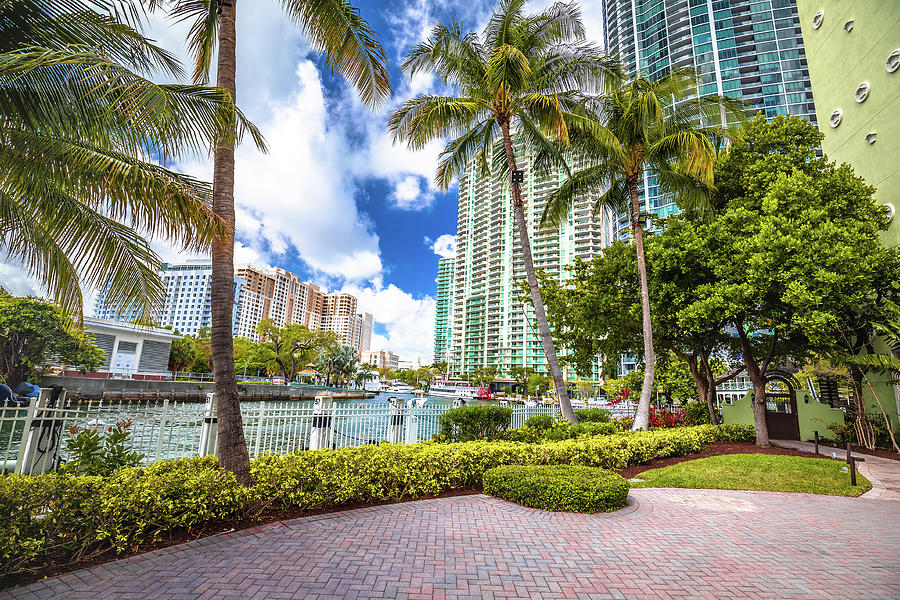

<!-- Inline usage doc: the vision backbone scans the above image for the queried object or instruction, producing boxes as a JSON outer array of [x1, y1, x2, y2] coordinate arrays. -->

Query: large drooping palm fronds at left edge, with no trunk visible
[[0, 0, 262, 317]]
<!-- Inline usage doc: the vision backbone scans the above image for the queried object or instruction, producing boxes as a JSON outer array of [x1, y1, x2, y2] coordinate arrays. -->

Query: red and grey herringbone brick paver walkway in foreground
[[0, 489, 900, 600]]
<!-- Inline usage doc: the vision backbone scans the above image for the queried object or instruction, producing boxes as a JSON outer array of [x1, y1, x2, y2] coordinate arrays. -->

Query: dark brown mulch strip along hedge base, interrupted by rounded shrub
[[0, 443, 856, 589]]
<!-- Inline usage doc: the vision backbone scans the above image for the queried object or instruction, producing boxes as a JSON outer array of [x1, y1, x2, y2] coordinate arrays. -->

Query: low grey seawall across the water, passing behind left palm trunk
[[41, 377, 373, 402]]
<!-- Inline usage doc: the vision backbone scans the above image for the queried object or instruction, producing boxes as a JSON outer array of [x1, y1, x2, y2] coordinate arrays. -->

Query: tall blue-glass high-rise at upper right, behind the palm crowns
[[602, 0, 816, 234]]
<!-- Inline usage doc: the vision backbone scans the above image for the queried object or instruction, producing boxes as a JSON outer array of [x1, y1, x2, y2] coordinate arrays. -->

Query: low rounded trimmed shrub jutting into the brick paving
[[484, 465, 629, 513]]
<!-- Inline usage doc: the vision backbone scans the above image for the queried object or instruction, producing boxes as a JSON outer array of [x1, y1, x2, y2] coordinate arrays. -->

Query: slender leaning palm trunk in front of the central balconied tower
[[500, 121, 578, 423]]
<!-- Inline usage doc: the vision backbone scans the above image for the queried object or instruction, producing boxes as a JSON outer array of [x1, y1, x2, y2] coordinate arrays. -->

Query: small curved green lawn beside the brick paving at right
[[631, 454, 872, 496]]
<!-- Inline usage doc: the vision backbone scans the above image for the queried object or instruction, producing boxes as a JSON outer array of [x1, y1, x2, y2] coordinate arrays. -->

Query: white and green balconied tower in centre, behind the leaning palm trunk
[[447, 144, 611, 375]]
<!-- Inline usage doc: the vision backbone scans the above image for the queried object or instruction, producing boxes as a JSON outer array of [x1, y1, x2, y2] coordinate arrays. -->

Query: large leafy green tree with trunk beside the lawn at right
[[682, 116, 887, 446]]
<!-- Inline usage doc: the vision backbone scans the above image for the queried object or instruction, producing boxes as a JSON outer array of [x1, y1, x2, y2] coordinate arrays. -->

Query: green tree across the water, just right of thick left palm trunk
[[254, 319, 339, 383]]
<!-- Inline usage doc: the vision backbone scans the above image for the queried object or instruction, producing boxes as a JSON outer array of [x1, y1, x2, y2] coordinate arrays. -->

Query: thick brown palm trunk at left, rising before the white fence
[[210, 3, 250, 485]]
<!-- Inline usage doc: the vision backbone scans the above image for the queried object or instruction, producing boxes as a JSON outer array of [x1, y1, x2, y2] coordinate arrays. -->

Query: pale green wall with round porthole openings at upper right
[[797, 0, 900, 244]]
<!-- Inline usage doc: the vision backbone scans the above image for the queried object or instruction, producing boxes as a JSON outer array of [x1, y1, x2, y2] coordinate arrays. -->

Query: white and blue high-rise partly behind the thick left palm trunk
[[94, 259, 245, 335]]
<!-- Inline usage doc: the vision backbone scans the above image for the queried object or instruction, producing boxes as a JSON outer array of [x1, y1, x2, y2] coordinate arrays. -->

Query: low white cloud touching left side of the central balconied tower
[[341, 284, 435, 364]]
